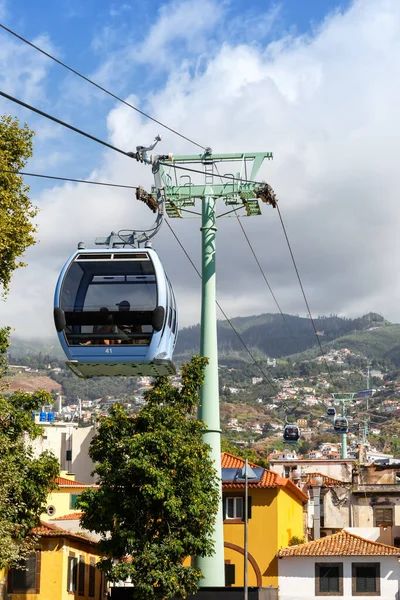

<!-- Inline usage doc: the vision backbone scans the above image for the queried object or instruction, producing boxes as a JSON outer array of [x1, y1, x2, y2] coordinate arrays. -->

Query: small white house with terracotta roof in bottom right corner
[[278, 530, 400, 600]]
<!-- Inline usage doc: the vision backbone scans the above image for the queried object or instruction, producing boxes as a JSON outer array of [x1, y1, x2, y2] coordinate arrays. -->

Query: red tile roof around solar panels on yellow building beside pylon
[[221, 452, 308, 502]]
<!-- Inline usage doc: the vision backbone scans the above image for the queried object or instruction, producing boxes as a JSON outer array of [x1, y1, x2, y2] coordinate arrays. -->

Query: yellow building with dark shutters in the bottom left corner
[[6, 522, 106, 600]]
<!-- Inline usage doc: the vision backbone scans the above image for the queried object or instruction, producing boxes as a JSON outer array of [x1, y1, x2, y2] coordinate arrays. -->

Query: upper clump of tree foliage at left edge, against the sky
[[0, 116, 37, 293]]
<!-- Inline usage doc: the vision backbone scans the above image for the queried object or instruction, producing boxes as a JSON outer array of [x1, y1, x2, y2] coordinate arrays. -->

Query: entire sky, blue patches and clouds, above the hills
[[0, 0, 400, 338]]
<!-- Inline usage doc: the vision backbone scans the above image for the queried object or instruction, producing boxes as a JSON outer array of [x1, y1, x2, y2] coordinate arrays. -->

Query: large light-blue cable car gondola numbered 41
[[54, 243, 178, 377]]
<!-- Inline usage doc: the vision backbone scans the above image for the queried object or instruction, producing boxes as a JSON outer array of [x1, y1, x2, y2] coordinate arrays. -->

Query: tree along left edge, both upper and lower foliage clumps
[[0, 116, 59, 569]]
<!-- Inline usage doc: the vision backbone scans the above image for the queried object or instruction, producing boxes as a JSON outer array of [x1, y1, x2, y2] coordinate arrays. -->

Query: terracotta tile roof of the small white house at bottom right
[[278, 529, 400, 558]]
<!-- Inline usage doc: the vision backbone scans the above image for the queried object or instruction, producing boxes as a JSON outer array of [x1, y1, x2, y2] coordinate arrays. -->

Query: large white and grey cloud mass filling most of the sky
[[2, 0, 400, 342]]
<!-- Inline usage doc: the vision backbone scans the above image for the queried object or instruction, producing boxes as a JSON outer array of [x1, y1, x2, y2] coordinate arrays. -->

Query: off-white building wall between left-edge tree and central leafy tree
[[32, 422, 96, 483]]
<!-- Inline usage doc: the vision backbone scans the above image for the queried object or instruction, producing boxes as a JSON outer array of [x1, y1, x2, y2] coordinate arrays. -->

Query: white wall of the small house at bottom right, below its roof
[[278, 556, 400, 600]]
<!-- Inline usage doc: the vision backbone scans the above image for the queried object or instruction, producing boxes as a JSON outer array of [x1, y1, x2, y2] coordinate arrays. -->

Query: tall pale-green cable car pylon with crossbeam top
[[150, 148, 276, 587]]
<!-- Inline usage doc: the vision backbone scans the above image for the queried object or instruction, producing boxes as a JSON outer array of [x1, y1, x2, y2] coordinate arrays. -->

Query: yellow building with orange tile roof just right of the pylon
[[221, 452, 308, 587]]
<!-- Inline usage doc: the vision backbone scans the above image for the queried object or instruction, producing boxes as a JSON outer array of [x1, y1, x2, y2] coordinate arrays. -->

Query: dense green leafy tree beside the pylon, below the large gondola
[[79, 356, 218, 599]]
